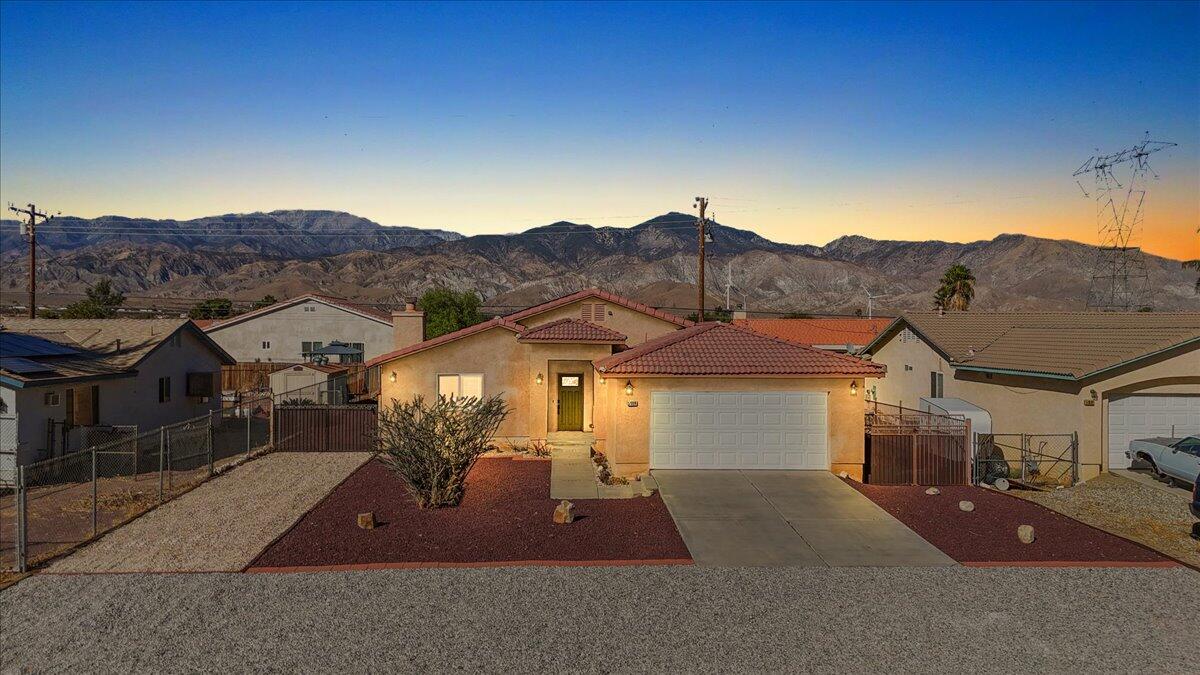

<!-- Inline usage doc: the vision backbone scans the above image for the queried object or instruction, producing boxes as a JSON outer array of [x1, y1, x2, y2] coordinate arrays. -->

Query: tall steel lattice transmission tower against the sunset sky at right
[[1072, 133, 1176, 311]]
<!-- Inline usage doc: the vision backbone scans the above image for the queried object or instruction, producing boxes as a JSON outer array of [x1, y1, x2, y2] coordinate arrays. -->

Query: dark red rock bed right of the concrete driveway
[[847, 480, 1174, 566]]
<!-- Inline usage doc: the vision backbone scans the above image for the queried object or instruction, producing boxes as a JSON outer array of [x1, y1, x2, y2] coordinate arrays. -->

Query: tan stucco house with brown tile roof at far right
[[865, 311, 1200, 479]]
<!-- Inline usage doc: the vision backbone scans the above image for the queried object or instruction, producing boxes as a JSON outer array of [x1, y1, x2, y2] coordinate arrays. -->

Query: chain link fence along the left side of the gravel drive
[[0, 399, 272, 572]]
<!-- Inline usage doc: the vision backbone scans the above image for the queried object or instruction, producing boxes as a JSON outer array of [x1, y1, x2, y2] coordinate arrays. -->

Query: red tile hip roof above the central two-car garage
[[594, 322, 884, 377]]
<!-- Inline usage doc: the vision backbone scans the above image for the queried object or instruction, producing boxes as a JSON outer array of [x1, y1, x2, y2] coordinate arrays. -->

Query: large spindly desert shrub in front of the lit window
[[378, 396, 509, 508]]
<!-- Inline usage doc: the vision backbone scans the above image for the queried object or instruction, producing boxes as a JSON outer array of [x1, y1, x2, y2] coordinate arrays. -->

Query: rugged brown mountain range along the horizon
[[0, 210, 1200, 312]]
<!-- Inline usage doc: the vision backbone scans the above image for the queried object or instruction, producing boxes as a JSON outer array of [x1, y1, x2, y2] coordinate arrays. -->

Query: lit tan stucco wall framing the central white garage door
[[596, 376, 865, 480]]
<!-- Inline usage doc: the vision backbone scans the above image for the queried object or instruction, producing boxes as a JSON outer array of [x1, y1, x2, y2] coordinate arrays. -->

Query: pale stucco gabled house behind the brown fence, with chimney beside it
[[204, 294, 425, 363]]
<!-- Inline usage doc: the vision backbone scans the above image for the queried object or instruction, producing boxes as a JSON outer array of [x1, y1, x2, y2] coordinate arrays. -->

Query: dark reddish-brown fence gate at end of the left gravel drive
[[275, 405, 378, 453]]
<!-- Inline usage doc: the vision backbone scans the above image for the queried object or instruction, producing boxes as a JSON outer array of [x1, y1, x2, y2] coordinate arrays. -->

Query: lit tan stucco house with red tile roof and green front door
[[368, 289, 883, 477]]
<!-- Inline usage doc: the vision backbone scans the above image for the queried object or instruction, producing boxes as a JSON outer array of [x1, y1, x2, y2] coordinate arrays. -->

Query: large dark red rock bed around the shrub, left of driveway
[[250, 458, 691, 569]]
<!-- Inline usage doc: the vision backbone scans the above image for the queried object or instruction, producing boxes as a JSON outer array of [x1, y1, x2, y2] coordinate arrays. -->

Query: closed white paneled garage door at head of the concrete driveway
[[650, 392, 829, 470]]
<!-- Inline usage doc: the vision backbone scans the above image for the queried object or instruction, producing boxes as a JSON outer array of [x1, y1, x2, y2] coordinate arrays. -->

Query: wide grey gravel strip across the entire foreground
[[0, 567, 1200, 674]]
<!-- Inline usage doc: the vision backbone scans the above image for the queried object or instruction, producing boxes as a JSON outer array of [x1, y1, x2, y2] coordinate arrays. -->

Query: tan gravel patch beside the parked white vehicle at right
[[1012, 473, 1200, 567]]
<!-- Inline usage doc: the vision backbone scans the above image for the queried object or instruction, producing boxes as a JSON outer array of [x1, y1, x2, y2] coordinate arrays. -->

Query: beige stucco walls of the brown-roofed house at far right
[[874, 329, 1200, 479]]
